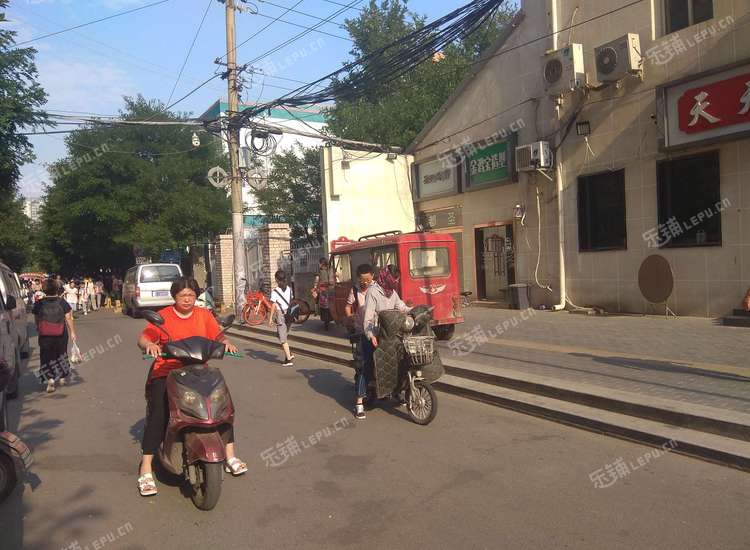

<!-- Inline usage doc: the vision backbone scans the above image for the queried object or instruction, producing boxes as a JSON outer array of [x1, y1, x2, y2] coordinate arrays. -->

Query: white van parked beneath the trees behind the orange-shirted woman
[[122, 264, 182, 317]]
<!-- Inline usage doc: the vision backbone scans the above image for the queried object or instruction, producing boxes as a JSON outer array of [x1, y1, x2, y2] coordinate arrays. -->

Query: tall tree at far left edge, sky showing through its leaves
[[0, 0, 48, 270]]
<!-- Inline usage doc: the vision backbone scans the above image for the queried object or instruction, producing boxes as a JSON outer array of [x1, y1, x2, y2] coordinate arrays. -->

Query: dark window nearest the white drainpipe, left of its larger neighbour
[[578, 170, 628, 252]]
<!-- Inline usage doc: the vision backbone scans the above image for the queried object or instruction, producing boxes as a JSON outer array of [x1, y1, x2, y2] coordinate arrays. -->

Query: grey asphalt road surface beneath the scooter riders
[[0, 312, 750, 550]]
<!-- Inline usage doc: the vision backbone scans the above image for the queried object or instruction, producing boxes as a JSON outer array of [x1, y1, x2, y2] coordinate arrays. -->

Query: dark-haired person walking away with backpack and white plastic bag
[[32, 279, 76, 393]]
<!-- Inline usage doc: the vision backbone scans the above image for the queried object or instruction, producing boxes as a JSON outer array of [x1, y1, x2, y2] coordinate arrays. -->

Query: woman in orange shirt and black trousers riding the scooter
[[138, 277, 247, 496]]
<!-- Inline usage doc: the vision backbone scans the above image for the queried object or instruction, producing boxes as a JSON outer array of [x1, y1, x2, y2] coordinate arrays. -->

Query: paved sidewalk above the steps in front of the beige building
[[284, 308, 750, 414]]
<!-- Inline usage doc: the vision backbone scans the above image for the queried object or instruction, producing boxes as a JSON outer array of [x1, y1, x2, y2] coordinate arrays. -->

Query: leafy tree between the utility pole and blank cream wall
[[255, 144, 323, 243]]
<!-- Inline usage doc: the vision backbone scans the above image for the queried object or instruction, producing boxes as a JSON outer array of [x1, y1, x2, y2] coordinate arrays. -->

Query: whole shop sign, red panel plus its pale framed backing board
[[663, 65, 750, 147]]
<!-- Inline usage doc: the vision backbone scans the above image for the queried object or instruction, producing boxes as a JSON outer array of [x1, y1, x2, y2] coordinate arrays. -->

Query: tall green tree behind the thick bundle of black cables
[[326, 0, 512, 147]]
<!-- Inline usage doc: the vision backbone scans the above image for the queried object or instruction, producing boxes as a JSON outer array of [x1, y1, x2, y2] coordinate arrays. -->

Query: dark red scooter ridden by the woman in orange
[[142, 310, 236, 510]]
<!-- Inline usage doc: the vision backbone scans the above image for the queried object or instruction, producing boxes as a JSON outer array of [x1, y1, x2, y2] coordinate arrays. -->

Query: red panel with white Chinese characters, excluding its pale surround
[[677, 73, 750, 134]]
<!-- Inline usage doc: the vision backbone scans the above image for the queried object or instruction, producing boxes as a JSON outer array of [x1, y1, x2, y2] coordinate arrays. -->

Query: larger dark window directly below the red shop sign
[[657, 151, 723, 247]]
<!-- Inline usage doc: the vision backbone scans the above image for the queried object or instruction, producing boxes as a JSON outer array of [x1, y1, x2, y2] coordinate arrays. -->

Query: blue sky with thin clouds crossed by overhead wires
[[6, 0, 500, 197]]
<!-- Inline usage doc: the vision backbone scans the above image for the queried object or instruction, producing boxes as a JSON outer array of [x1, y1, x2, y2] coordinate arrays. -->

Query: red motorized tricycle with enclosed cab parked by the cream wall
[[331, 231, 464, 340]]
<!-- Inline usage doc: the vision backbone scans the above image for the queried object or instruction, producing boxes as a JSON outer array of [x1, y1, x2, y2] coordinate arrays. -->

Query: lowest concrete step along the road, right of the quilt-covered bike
[[435, 375, 750, 471]]
